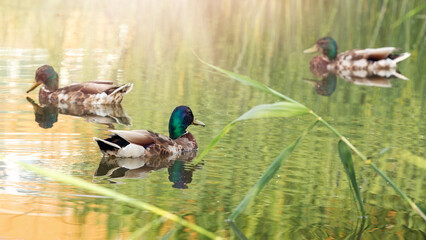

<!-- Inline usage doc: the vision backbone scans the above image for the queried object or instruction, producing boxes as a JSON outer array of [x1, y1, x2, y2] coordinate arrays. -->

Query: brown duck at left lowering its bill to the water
[[27, 65, 133, 105]]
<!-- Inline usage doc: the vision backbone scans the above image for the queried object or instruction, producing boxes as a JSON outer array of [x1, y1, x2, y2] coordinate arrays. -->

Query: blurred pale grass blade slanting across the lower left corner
[[18, 162, 221, 239]]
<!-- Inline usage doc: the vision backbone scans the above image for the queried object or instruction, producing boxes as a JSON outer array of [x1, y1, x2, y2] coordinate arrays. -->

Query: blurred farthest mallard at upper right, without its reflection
[[303, 37, 410, 80]]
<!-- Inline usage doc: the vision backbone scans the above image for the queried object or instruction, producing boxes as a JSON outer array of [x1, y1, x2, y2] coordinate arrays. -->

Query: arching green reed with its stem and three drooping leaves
[[193, 59, 426, 225]]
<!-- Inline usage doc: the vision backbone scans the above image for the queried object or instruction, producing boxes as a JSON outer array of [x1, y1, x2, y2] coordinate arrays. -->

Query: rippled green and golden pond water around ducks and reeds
[[0, 0, 426, 239]]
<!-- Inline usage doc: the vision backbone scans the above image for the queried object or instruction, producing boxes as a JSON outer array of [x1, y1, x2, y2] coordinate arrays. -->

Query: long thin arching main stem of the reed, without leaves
[[198, 58, 426, 221]]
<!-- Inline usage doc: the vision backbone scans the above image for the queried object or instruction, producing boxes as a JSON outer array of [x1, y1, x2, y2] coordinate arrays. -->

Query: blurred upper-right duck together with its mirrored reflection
[[304, 37, 410, 96]]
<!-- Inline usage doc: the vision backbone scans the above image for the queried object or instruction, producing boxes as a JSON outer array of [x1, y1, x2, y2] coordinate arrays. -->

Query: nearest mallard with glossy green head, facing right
[[93, 106, 205, 158]]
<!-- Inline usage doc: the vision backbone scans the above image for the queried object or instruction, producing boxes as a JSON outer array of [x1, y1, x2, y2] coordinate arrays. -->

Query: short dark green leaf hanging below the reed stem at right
[[337, 140, 365, 217]]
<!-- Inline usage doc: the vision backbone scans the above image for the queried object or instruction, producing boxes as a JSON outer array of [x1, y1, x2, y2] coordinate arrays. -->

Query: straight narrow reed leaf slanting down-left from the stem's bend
[[228, 121, 318, 221]]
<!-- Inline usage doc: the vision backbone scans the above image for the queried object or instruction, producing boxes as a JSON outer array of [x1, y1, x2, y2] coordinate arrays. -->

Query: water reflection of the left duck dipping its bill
[[27, 97, 132, 129]]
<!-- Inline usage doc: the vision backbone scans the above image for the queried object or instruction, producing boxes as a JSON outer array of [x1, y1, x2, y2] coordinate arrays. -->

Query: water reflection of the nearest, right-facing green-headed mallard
[[94, 151, 196, 189]]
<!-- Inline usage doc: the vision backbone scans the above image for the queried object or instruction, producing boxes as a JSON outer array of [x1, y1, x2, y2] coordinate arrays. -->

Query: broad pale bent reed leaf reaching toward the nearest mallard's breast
[[191, 102, 309, 165]]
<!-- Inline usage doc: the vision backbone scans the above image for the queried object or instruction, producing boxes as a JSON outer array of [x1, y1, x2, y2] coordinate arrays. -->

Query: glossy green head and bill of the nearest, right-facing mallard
[[169, 106, 205, 139]]
